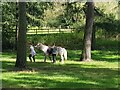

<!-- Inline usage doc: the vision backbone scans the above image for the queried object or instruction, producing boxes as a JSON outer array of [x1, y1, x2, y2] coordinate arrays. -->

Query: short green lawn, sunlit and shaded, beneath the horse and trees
[[0, 50, 119, 88]]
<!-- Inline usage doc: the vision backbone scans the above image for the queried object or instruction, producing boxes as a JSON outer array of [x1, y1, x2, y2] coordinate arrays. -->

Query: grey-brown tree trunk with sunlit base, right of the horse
[[80, 2, 94, 61]]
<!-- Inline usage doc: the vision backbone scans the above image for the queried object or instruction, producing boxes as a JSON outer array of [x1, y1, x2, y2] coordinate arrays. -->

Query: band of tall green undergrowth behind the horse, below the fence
[[27, 30, 120, 50]]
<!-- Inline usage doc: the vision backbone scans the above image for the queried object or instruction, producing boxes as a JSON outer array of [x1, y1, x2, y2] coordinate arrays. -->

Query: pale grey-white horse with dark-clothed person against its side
[[35, 43, 67, 63]]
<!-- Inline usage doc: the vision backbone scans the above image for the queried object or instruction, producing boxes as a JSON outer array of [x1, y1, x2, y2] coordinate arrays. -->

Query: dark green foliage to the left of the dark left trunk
[[2, 2, 17, 49]]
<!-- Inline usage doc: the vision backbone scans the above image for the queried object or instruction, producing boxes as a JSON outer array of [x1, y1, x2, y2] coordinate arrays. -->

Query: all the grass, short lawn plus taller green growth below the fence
[[0, 33, 120, 90]]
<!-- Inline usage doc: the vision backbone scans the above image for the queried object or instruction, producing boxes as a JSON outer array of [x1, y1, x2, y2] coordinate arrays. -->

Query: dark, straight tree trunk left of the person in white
[[15, 2, 26, 68]]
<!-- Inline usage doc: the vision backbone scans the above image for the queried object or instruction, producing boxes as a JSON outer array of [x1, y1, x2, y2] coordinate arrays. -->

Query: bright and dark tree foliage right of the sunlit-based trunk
[[94, 2, 120, 38]]
